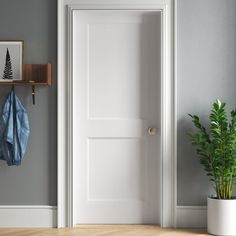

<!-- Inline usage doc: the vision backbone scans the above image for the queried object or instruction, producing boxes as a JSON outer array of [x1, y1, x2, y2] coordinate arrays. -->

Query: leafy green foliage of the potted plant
[[187, 99, 236, 199]]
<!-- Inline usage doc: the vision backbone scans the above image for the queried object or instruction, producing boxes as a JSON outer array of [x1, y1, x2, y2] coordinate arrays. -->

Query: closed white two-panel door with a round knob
[[72, 10, 161, 224]]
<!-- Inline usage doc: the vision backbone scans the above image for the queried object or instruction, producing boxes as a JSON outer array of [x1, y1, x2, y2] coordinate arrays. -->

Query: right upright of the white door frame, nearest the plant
[[161, 2, 176, 227]]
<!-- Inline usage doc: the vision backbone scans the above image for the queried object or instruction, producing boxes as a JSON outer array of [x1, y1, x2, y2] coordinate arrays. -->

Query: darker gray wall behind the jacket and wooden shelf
[[0, 0, 57, 205]]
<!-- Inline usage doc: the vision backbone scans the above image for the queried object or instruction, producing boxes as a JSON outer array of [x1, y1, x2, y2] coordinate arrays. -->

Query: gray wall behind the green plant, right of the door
[[177, 0, 236, 205]]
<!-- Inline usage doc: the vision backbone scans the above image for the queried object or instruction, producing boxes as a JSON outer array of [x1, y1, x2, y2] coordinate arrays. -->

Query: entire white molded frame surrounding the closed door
[[57, 0, 176, 227]]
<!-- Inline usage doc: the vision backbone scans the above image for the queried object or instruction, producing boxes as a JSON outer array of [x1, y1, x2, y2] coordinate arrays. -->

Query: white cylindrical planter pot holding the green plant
[[207, 198, 236, 236]]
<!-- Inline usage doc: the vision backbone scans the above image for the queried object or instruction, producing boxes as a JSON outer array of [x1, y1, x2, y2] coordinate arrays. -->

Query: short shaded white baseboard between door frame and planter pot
[[176, 206, 207, 228]]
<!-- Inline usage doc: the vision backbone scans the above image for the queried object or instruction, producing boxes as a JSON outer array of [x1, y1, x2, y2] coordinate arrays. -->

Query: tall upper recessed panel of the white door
[[88, 19, 146, 118]]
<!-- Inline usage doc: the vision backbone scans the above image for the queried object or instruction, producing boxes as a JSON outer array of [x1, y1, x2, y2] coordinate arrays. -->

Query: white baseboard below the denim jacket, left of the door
[[0, 205, 57, 228]]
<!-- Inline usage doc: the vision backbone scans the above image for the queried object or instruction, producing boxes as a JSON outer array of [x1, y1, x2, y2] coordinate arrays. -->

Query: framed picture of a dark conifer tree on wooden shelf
[[0, 41, 23, 82]]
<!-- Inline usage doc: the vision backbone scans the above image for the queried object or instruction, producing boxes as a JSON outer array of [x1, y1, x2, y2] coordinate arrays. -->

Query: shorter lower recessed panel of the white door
[[87, 138, 145, 201]]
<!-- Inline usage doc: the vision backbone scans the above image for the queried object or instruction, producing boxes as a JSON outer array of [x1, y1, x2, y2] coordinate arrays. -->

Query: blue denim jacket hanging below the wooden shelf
[[0, 90, 30, 166]]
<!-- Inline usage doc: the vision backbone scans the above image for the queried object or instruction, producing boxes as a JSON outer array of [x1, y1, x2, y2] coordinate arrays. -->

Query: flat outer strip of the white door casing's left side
[[57, 0, 67, 227]]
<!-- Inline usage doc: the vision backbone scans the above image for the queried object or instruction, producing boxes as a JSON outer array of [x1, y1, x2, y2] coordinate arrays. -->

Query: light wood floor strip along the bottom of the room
[[0, 225, 208, 236]]
